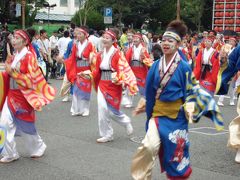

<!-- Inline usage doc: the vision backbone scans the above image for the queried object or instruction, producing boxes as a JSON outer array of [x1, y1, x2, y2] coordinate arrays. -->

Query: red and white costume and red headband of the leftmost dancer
[[0, 30, 56, 162]]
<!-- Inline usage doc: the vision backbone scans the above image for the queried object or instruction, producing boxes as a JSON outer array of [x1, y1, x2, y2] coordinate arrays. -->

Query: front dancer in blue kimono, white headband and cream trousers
[[131, 20, 223, 180]]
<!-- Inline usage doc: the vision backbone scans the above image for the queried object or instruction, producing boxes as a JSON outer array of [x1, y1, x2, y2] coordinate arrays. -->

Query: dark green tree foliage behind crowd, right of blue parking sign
[[96, 0, 212, 31]]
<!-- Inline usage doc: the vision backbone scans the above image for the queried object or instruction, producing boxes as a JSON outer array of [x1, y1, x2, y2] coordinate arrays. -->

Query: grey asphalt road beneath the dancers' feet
[[0, 80, 240, 180]]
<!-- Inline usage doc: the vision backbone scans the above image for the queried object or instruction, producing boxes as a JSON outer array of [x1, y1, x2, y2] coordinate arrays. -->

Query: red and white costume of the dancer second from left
[[65, 35, 95, 116]]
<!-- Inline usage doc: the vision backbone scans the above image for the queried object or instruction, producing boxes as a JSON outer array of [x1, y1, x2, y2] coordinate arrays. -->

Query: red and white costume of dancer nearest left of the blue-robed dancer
[[92, 42, 137, 139]]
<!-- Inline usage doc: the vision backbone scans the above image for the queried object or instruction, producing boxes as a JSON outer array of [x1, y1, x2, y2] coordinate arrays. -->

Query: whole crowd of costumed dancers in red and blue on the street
[[0, 20, 240, 180]]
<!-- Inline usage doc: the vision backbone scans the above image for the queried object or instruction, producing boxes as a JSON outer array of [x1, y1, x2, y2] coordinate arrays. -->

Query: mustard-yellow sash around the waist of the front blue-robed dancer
[[152, 99, 183, 119]]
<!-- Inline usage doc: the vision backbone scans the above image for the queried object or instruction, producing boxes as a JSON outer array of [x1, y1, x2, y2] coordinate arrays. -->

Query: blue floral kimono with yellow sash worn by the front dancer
[[146, 51, 223, 179]]
